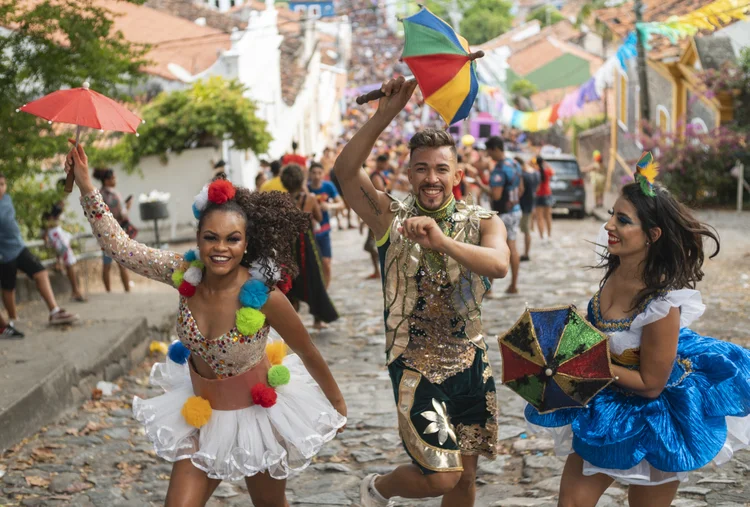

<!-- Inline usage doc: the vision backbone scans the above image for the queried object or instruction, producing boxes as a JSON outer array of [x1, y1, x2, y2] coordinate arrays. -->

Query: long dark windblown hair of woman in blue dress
[[599, 183, 720, 310]]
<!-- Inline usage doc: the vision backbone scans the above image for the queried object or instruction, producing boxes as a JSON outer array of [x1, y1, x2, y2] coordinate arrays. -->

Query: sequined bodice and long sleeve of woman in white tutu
[[81, 191, 269, 377]]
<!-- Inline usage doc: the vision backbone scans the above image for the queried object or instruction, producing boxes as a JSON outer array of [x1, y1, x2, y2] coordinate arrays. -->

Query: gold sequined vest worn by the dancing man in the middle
[[378, 195, 493, 382]]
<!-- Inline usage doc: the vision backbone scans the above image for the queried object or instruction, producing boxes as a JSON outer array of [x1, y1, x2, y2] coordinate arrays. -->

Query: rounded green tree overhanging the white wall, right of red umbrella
[[113, 76, 271, 170]]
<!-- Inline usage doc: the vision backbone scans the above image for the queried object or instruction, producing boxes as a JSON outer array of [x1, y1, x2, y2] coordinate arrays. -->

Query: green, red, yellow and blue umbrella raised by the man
[[401, 7, 484, 125]]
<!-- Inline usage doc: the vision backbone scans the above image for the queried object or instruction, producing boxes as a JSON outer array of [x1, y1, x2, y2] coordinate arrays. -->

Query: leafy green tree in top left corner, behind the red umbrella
[[0, 0, 147, 238]]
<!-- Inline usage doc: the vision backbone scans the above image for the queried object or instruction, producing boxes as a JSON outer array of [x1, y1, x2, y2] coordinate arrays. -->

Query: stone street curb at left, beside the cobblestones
[[0, 318, 167, 454]]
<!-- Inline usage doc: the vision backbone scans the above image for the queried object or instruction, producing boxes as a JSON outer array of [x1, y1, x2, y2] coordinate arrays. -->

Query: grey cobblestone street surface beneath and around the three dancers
[[0, 213, 750, 507]]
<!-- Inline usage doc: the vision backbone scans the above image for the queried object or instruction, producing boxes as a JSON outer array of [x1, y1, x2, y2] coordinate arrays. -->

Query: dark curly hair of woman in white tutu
[[198, 187, 310, 285]]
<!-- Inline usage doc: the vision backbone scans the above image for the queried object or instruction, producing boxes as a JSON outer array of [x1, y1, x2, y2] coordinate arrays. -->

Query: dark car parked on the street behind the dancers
[[544, 154, 586, 218]]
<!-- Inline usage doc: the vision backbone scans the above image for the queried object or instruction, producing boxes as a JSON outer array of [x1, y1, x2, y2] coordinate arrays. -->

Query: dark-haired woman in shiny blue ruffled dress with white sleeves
[[525, 165, 750, 507]]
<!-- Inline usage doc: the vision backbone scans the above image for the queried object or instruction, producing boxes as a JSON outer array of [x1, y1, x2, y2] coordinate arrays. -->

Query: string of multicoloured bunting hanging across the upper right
[[472, 0, 750, 132]]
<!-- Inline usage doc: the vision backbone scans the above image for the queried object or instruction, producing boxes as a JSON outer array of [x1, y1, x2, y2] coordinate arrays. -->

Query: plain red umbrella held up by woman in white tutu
[[17, 83, 143, 192]]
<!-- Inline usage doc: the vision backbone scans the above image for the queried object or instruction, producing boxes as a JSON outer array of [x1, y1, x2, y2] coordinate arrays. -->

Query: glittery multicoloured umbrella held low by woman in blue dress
[[498, 306, 614, 414]]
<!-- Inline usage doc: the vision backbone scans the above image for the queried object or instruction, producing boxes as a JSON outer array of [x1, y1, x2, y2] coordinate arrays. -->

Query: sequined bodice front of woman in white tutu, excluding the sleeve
[[177, 297, 270, 378]]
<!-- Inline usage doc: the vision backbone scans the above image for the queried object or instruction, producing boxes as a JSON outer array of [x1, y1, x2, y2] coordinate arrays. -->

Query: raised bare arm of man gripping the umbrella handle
[[333, 77, 417, 238]]
